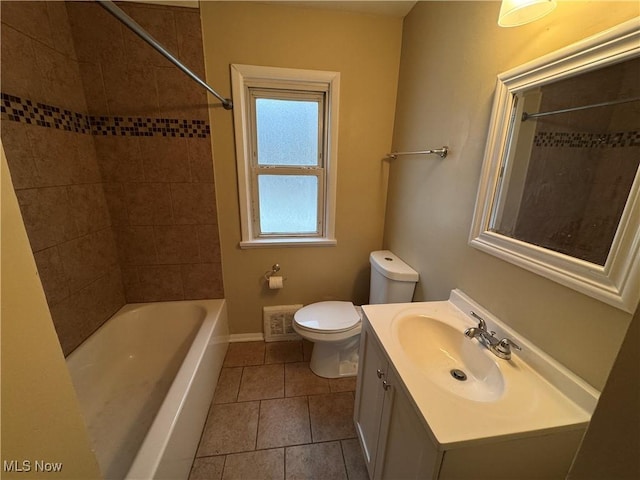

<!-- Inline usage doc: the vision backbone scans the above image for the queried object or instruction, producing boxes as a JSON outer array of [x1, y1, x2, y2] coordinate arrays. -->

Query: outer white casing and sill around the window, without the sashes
[[231, 64, 340, 248]]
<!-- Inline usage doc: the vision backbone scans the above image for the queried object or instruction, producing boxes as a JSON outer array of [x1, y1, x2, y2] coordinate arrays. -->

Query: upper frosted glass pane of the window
[[256, 98, 318, 165]]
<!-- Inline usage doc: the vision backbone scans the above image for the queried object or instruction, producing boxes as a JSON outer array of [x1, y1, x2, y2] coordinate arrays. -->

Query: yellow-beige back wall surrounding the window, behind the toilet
[[201, 2, 402, 334]]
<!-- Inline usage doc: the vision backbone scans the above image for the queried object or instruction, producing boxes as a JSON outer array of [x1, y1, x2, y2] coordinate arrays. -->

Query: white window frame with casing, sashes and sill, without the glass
[[231, 64, 340, 248]]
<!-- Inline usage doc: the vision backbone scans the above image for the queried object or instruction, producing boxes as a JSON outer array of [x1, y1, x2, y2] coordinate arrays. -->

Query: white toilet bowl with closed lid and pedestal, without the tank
[[293, 301, 362, 378]]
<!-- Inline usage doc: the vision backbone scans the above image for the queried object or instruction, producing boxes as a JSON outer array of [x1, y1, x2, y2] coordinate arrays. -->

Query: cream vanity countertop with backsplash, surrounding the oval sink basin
[[363, 290, 599, 449]]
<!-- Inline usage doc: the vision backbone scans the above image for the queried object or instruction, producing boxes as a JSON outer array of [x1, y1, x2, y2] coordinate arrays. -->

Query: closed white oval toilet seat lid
[[294, 301, 360, 333]]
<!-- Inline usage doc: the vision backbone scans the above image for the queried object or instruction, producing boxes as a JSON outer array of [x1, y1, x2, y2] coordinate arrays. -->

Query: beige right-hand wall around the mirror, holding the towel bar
[[384, 2, 639, 389]]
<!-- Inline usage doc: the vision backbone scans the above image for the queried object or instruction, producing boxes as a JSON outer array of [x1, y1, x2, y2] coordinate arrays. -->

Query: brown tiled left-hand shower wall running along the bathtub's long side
[[0, 2, 125, 353]]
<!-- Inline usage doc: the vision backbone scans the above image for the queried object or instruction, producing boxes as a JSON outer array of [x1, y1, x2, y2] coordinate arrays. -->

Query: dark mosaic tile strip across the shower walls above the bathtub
[[0, 92, 211, 138]]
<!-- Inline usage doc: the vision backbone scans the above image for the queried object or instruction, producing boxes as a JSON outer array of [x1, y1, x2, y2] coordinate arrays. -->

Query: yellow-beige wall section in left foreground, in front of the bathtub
[[0, 145, 100, 479]]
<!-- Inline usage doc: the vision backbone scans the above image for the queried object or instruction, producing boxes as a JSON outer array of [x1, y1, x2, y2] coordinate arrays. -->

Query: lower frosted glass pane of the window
[[258, 175, 318, 234]]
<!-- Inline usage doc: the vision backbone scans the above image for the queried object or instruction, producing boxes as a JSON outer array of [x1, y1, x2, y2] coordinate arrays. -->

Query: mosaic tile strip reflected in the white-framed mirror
[[534, 130, 640, 148]]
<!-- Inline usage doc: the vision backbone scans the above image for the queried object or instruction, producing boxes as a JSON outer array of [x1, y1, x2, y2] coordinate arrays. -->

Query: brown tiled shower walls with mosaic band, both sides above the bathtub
[[0, 2, 223, 354]]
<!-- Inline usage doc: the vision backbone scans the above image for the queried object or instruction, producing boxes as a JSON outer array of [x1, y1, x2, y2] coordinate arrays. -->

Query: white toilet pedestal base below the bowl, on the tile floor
[[309, 334, 360, 378]]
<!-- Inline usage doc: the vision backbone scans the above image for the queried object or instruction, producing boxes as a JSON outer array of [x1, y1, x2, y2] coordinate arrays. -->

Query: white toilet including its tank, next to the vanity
[[293, 250, 418, 378]]
